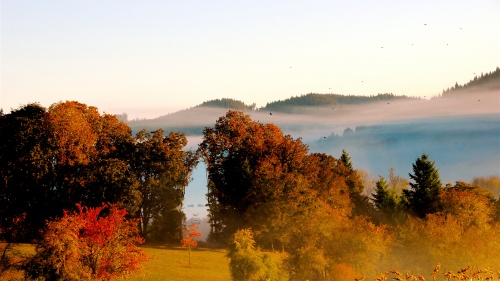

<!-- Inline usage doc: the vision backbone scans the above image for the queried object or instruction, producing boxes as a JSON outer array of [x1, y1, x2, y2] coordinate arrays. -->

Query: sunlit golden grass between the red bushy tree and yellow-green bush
[[121, 245, 231, 281]]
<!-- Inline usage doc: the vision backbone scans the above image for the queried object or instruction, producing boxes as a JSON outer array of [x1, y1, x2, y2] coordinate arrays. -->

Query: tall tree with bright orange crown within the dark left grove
[[46, 101, 140, 212]]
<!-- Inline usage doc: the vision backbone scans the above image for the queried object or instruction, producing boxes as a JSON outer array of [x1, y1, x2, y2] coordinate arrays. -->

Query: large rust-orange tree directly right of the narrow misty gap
[[198, 111, 309, 240]]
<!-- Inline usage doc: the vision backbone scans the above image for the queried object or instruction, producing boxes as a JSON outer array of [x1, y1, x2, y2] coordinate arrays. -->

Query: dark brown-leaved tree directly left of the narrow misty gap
[[130, 129, 196, 241]]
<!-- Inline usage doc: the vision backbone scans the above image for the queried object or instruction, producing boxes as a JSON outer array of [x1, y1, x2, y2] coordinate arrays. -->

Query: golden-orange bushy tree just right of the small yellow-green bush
[[286, 197, 391, 280]]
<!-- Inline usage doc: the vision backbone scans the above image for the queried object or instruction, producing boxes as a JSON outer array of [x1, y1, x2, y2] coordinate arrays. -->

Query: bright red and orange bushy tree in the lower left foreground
[[26, 204, 149, 280]]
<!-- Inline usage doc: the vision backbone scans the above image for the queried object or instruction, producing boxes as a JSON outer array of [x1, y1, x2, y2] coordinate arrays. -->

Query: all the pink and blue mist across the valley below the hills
[[178, 88, 500, 183]]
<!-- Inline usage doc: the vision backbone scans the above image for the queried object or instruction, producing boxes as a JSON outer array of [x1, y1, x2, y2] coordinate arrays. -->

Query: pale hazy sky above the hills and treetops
[[0, 0, 500, 118]]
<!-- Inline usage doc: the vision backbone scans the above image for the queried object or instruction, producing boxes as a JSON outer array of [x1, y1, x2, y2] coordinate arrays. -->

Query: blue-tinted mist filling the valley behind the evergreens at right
[[309, 114, 500, 183]]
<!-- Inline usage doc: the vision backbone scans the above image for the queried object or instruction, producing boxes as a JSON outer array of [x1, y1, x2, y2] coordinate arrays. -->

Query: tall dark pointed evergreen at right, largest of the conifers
[[403, 153, 442, 218]]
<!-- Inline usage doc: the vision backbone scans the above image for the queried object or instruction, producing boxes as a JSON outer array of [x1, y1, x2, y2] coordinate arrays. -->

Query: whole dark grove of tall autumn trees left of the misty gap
[[0, 101, 196, 241]]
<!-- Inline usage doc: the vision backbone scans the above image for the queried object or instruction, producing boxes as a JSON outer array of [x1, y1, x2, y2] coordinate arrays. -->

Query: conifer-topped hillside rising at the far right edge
[[442, 67, 500, 98]]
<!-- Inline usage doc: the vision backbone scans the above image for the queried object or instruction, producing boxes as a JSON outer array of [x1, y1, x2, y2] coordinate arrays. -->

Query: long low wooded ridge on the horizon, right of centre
[[259, 93, 418, 113]]
